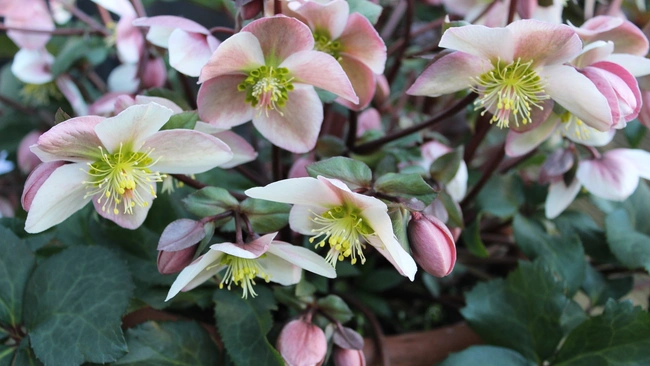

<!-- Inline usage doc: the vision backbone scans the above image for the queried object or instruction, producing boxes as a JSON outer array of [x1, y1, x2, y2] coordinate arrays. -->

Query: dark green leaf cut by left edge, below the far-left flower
[[0, 227, 36, 327]]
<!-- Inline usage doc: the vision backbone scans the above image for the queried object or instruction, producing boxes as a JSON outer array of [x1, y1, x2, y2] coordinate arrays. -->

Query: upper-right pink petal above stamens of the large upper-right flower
[[506, 19, 582, 67]]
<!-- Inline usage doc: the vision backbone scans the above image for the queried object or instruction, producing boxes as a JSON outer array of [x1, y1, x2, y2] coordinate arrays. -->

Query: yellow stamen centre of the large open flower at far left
[[83, 144, 166, 215]]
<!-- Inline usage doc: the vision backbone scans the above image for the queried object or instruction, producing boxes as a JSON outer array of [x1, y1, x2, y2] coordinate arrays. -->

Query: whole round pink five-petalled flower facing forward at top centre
[[198, 16, 359, 153]]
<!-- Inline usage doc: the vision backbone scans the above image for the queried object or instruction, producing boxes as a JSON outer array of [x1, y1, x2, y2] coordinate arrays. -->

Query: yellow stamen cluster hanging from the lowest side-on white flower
[[219, 254, 271, 299]]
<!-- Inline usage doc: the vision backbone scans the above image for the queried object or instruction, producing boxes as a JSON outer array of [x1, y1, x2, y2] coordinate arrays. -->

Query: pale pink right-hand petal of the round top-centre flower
[[279, 51, 359, 104]]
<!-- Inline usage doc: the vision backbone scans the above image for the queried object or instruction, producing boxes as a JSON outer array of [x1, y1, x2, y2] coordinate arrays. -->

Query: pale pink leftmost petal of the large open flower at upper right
[[406, 52, 494, 97]]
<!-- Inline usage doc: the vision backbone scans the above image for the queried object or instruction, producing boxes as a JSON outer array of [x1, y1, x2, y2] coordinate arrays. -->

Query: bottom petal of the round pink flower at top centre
[[253, 84, 324, 154]]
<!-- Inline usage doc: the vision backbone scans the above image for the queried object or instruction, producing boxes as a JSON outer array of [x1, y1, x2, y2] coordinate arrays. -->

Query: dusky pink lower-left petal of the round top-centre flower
[[197, 73, 254, 128]]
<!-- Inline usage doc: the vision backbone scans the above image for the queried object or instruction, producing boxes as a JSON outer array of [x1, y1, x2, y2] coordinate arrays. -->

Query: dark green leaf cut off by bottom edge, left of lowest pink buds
[[115, 321, 219, 366]]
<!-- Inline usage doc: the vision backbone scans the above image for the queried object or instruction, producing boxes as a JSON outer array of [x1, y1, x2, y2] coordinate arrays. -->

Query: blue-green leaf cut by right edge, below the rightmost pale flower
[[605, 208, 650, 271]]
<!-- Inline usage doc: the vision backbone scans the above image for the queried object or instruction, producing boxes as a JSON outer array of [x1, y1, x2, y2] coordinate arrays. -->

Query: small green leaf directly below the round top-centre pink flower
[[307, 156, 372, 189]]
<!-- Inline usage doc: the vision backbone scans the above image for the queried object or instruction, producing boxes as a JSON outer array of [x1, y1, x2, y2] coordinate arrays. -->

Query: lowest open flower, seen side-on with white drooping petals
[[165, 233, 336, 301]]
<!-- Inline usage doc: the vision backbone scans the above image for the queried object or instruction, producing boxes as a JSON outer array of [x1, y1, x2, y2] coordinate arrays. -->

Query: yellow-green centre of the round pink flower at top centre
[[237, 66, 293, 116]]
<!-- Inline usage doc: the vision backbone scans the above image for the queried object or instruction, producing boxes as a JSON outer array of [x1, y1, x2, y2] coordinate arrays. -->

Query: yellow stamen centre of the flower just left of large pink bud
[[309, 206, 375, 267]]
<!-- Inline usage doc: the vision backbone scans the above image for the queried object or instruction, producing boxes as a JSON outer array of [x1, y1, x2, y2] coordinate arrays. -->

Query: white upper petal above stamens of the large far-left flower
[[95, 103, 174, 153]]
